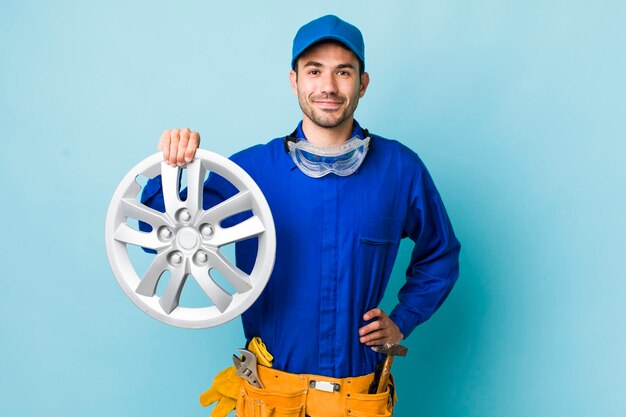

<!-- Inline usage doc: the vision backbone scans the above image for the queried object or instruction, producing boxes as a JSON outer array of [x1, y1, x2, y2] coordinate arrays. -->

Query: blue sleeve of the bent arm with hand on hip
[[390, 161, 461, 338]]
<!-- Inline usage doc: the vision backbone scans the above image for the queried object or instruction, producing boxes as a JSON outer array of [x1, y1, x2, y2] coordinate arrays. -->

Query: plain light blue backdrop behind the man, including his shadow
[[0, 0, 626, 417]]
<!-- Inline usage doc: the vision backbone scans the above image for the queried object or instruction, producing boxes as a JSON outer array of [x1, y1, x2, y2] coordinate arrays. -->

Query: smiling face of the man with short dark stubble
[[289, 42, 369, 129]]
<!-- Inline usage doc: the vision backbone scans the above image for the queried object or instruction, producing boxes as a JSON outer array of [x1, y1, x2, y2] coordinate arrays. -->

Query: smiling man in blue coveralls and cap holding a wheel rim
[[143, 15, 460, 416]]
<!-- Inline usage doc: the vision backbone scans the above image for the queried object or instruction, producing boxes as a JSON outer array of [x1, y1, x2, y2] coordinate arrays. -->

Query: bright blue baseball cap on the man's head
[[291, 14, 365, 70]]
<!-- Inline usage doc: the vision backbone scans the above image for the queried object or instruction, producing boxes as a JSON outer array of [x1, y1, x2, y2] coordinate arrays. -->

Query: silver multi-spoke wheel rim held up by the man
[[105, 149, 276, 329]]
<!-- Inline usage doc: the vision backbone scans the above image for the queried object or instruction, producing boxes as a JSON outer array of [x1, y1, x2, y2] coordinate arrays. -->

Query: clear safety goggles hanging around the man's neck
[[287, 136, 370, 178]]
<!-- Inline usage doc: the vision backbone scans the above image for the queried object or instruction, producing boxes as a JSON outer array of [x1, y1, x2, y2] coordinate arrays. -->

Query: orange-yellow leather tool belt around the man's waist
[[235, 365, 394, 417]]
